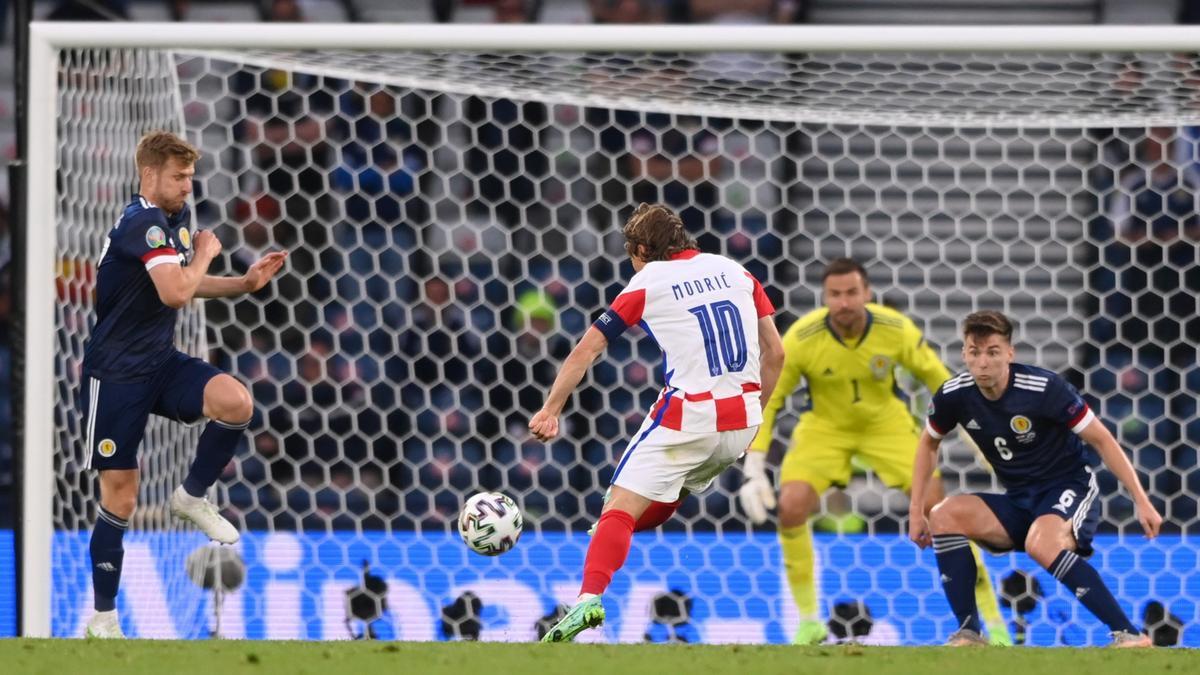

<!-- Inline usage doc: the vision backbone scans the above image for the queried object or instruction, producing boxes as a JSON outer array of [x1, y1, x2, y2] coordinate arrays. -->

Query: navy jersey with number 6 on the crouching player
[[925, 363, 1096, 489]]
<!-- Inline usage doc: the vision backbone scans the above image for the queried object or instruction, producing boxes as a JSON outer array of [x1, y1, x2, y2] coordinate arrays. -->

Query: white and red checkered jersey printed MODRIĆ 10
[[594, 250, 775, 432]]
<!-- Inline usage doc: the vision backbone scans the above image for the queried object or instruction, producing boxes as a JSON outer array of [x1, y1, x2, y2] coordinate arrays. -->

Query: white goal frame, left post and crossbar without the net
[[18, 22, 1200, 637]]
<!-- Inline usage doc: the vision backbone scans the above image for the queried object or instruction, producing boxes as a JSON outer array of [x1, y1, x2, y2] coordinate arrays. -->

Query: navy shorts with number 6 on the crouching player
[[974, 470, 1100, 557]]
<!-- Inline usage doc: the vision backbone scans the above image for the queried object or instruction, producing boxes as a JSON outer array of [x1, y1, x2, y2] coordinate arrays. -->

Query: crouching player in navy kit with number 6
[[908, 311, 1163, 647]]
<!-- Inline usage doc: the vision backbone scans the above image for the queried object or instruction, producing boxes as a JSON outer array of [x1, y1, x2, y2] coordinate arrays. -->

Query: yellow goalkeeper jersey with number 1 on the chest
[[751, 303, 950, 450]]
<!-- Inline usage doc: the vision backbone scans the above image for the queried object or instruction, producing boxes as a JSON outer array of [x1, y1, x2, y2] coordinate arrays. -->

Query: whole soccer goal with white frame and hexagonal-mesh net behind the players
[[19, 23, 1200, 644]]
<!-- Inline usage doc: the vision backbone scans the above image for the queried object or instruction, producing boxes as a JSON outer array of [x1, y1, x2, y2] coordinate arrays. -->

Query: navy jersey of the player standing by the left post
[[83, 195, 192, 382]]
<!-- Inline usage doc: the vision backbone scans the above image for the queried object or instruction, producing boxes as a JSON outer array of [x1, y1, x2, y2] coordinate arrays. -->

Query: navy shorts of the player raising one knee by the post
[[80, 352, 221, 471]]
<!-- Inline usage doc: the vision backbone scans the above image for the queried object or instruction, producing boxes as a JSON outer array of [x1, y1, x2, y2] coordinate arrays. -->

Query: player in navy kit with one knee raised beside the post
[[80, 131, 287, 638]]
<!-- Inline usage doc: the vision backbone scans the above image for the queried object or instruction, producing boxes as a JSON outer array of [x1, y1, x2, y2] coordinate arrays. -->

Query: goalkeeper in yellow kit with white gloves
[[738, 258, 1012, 645]]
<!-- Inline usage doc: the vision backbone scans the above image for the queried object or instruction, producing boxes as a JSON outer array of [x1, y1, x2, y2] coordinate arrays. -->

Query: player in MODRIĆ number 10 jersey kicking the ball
[[529, 204, 784, 643]]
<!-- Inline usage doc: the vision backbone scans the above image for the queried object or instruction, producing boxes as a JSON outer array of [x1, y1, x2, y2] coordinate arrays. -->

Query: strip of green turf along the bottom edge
[[0, 640, 1200, 675]]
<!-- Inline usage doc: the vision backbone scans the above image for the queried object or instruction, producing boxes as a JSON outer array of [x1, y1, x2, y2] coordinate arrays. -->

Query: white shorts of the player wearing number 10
[[612, 418, 758, 502]]
